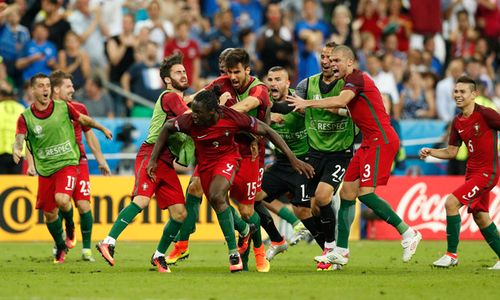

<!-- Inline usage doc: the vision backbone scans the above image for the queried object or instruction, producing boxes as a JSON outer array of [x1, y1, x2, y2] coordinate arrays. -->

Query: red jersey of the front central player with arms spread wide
[[174, 106, 257, 170]]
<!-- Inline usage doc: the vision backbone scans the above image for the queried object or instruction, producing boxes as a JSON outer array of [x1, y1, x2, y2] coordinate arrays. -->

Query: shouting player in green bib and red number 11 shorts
[[13, 73, 112, 263]]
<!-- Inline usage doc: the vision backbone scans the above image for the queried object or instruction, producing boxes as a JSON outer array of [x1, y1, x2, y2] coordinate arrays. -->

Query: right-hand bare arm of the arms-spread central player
[[257, 121, 314, 178]]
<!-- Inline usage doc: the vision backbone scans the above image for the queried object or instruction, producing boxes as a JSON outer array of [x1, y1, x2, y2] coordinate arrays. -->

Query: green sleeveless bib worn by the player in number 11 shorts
[[23, 100, 80, 176]]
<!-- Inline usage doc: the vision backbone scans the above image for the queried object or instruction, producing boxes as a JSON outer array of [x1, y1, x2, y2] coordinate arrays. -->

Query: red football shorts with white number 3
[[344, 140, 399, 187]]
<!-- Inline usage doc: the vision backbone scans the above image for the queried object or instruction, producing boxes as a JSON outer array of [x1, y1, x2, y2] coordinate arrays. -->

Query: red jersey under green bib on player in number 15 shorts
[[206, 75, 271, 159]]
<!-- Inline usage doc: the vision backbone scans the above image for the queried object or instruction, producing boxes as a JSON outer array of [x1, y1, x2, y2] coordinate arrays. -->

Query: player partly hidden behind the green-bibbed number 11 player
[[49, 71, 111, 262]]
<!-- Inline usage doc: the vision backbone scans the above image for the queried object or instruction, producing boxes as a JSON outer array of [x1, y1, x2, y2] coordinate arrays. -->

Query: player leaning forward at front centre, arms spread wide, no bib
[[147, 91, 314, 272]]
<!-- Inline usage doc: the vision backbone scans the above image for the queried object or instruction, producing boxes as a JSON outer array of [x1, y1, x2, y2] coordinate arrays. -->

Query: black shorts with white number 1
[[262, 157, 311, 207]]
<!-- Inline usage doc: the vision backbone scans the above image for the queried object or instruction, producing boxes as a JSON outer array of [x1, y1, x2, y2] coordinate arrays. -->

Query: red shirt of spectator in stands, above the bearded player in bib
[[163, 39, 201, 85]]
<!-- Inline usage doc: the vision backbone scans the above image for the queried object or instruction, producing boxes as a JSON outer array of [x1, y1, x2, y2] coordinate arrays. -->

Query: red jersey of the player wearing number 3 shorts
[[343, 69, 399, 145]]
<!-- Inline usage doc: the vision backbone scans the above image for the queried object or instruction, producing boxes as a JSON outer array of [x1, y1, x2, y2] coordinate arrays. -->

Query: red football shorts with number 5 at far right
[[452, 173, 498, 213]]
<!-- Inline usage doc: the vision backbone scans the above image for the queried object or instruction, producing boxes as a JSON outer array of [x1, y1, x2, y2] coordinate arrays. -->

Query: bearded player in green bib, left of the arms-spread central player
[[97, 55, 189, 273]]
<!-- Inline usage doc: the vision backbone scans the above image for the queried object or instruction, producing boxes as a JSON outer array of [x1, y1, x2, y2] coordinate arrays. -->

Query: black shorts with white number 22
[[307, 149, 353, 197]]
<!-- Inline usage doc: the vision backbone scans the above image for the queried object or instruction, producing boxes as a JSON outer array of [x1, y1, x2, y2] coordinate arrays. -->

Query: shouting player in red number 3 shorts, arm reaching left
[[287, 45, 422, 265]]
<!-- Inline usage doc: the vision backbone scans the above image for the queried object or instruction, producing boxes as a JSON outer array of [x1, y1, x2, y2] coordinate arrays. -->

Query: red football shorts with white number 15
[[229, 157, 260, 204]]
